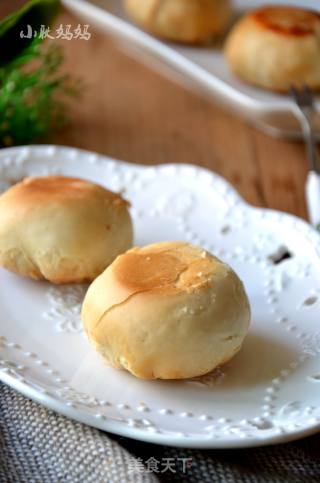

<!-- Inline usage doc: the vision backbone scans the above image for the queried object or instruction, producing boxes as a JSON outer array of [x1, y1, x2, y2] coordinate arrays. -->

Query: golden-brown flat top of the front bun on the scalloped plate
[[113, 242, 226, 293]]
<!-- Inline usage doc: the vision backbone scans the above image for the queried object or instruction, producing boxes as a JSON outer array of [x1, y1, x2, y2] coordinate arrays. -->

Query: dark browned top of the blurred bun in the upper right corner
[[249, 5, 320, 37]]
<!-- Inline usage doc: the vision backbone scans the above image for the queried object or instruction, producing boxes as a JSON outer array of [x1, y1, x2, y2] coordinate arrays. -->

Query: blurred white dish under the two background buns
[[63, 0, 320, 137]]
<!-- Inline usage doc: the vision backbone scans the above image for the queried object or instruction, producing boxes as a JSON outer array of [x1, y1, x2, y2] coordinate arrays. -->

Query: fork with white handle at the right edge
[[290, 85, 320, 230]]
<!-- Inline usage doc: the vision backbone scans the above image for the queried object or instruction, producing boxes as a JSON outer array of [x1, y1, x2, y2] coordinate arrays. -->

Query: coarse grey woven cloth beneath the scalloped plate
[[0, 383, 320, 483]]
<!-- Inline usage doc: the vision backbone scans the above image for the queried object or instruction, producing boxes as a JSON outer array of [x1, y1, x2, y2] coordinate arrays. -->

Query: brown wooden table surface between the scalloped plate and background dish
[[52, 9, 316, 222]]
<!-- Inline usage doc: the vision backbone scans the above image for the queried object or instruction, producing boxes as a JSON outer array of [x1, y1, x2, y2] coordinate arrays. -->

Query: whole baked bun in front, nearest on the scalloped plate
[[82, 242, 250, 379]]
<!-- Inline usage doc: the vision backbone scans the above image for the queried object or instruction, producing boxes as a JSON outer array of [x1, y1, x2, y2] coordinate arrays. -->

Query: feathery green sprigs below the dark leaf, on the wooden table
[[0, 42, 81, 146]]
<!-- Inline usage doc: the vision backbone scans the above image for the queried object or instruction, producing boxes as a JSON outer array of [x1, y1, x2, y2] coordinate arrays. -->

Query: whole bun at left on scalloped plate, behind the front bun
[[0, 176, 132, 283]]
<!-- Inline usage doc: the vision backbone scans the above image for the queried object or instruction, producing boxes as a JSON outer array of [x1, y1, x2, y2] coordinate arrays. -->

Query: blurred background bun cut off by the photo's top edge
[[124, 0, 231, 43]]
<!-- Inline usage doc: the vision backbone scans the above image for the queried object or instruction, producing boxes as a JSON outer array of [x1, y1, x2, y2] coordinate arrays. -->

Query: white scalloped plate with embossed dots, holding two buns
[[0, 146, 320, 448]]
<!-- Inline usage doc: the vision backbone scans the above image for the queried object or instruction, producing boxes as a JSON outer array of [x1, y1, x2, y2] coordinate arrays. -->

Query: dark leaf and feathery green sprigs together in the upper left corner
[[0, 0, 81, 147]]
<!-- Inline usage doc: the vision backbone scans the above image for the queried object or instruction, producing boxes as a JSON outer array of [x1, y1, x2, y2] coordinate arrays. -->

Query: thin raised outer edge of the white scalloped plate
[[0, 145, 320, 448]]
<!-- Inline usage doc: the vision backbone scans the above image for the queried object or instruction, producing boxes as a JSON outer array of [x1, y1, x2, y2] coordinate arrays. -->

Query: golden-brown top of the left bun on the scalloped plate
[[3, 176, 128, 209]]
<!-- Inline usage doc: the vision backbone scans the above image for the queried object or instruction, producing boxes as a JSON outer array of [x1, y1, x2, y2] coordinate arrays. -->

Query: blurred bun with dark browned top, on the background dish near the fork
[[225, 6, 320, 92]]
